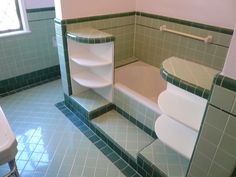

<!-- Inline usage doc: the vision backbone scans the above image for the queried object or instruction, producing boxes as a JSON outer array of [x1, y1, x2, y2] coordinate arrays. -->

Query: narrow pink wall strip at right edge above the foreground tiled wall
[[222, 25, 236, 80]]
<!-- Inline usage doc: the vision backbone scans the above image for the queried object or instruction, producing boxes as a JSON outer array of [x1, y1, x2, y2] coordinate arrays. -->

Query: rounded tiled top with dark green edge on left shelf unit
[[67, 28, 115, 44]]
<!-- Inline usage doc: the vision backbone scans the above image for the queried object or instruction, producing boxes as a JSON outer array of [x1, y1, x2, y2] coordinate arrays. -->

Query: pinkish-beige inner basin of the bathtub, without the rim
[[115, 61, 167, 103]]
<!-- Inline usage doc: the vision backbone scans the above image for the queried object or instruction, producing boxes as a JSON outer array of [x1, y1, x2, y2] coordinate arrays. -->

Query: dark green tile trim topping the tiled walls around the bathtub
[[55, 11, 233, 35]]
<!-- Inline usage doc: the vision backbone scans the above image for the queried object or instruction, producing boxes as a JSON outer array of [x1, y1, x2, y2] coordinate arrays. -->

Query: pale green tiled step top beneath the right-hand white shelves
[[139, 139, 189, 177]]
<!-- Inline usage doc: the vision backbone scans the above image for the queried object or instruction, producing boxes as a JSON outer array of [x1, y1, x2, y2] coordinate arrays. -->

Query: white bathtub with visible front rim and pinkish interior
[[115, 61, 166, 113]]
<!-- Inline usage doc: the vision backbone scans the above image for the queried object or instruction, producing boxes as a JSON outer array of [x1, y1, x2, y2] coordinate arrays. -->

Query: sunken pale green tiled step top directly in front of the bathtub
[[92, 110, 154, 160]]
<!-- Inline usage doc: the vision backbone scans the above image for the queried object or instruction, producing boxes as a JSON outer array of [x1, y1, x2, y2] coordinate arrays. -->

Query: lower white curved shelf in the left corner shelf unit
[[72, 72, 112, 88]]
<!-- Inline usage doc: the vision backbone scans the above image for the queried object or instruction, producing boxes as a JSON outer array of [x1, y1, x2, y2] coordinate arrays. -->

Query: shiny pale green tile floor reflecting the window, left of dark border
[[0, 80, 127, 177]]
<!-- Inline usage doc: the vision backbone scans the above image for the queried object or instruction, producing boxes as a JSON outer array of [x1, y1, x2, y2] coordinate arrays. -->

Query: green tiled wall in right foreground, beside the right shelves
[[188, 75, 236, 177]]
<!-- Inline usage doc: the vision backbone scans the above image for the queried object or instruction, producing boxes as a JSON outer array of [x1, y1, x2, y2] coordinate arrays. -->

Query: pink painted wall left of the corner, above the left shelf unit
[[55, 0, 135, 19]]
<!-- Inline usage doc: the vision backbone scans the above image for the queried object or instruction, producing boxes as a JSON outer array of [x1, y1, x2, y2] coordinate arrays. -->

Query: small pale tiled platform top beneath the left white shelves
[[72, 89, 109, 112]]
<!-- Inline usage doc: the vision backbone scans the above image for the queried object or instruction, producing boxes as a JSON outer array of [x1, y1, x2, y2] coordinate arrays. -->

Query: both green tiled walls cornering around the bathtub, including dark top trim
[[59, 12, 232, 70]]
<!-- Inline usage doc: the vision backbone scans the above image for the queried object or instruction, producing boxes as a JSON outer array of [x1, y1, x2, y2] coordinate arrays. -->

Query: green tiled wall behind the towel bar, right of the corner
[[134, 15, 231, 70]]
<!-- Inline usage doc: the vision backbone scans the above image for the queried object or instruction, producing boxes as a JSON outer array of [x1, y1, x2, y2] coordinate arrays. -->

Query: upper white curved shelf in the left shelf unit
[[71, 53, 112, 67]]
